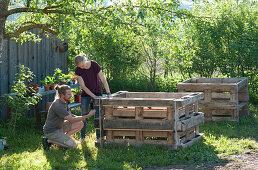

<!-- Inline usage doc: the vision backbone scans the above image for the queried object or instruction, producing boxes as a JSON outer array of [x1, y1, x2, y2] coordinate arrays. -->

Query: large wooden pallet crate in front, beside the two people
[[94, 91, 204, 149]]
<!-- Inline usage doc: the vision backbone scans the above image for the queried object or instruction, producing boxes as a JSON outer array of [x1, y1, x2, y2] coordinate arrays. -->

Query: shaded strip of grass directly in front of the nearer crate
[[79, 140, 225, 169]]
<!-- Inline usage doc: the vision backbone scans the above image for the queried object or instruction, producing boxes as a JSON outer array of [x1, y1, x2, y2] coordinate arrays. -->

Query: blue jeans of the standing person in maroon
[[81, 97, 100, 139]]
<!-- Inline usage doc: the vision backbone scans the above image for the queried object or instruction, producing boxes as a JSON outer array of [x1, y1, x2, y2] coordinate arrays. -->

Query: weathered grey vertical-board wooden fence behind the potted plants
[[0, 30, 68, 119]]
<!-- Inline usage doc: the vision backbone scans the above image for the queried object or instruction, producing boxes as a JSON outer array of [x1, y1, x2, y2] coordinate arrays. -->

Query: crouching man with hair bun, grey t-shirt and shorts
[[42, 85, 96, 149]]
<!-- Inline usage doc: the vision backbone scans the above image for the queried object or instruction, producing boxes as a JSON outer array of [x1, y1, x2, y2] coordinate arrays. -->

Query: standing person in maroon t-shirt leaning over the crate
[[74, 54, 111, 142]]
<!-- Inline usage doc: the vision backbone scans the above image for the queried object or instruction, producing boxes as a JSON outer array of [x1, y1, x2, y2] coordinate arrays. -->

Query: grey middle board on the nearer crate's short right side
[[177, 112, 204, 131]]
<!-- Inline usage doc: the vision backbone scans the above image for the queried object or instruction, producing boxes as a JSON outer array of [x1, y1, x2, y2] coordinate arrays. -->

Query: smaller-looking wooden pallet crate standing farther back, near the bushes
[[177, 77, 249, 121]]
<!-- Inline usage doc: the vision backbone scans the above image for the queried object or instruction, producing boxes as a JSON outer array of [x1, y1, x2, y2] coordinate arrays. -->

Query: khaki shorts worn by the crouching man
[[45, 120, 72, 145]]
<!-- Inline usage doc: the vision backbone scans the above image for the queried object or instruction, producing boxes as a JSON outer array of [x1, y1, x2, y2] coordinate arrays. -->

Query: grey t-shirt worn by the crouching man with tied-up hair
[[43, 99, 70, 134]]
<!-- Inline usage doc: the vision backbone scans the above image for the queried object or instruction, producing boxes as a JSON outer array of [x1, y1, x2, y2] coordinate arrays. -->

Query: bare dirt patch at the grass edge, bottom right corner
[[144, 152, 258, 170]]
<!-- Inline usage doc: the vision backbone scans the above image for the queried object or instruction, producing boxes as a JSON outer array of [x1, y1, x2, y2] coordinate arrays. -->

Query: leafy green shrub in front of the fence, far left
[[2, 65, 40, 130]]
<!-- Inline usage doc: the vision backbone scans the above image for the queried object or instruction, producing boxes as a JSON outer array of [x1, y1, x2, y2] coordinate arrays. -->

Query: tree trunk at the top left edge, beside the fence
[[0, 0, 9, 64]]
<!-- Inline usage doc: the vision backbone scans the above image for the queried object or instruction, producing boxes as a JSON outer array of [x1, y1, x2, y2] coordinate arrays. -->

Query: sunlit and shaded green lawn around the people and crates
[[0, 106, 258, 169]]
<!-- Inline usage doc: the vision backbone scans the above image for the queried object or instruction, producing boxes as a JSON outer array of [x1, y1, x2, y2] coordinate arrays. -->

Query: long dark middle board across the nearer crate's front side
[[103, 119, 174, 130]]
